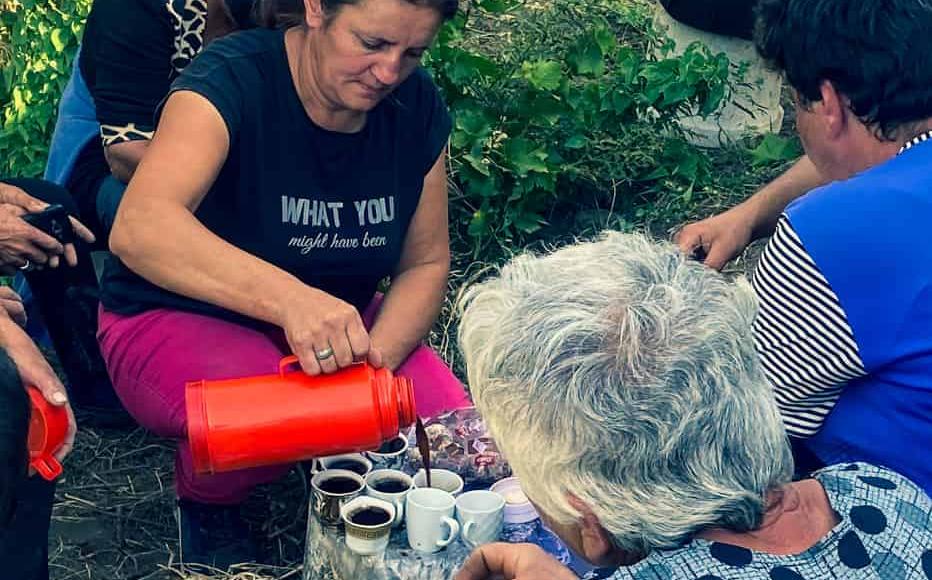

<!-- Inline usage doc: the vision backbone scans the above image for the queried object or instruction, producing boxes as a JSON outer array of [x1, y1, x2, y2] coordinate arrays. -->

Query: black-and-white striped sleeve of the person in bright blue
[[753, 215, 867, 437]]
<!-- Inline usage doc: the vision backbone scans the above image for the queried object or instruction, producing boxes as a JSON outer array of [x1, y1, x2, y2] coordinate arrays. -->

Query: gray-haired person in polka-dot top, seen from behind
[[459, 233, 932, 580]]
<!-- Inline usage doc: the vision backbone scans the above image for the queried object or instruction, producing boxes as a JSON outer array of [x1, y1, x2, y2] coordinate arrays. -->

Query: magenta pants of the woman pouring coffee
[[98, 296, 470, 504]]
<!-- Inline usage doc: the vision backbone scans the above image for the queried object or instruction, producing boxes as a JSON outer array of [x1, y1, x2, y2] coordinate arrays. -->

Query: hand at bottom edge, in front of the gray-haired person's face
[[456, 543, 576, 580]]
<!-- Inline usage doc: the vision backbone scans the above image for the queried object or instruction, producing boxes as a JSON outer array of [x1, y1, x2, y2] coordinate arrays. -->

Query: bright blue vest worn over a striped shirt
[[786, 141, 932, 492]]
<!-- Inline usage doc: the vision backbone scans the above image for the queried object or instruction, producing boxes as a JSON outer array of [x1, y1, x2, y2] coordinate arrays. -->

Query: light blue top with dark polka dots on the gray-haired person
[[611, 463, 932, 580]]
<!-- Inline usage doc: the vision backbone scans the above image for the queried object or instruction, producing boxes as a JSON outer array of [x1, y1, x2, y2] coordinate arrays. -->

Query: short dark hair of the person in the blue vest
[[755, 0, 932, 141]]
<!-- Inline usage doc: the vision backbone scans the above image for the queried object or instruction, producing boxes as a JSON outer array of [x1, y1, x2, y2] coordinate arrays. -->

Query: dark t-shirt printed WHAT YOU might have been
[[102, 30, 451, 322]]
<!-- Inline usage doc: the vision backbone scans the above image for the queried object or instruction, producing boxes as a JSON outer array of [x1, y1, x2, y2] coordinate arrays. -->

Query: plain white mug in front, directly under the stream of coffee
[[405, 488, 460, 554]]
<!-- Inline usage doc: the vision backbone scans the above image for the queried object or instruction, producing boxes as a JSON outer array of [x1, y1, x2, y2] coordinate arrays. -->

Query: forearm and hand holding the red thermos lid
[[0, 314, 78, 461]]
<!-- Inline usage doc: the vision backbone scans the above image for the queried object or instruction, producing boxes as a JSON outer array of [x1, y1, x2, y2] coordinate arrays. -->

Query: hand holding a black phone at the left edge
[[0, 183, 94, 274]]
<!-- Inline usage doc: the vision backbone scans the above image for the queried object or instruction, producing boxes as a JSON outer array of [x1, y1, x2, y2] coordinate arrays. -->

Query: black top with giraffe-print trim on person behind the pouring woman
[[66, 0, 213, 222]]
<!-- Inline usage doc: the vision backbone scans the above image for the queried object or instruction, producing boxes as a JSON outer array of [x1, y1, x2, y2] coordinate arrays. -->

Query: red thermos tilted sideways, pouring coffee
[[185, 356, 416, 473]]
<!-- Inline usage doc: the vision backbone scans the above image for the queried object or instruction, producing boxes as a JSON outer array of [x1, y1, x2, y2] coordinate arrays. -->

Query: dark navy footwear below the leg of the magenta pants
[[177, 499, 256, 570]]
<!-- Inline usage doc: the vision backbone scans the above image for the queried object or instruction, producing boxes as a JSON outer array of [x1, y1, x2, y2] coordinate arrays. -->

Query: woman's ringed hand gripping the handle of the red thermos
[[282, 287, 382, 375]]
